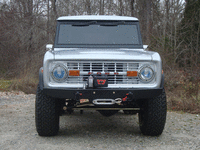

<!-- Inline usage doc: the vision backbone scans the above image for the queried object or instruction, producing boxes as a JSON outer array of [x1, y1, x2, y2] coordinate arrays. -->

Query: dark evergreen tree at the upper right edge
[[178, 0, 200, 66]]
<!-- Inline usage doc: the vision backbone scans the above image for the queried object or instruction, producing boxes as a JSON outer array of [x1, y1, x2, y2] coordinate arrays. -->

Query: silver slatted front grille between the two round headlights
[[66, 62, 139, 84]]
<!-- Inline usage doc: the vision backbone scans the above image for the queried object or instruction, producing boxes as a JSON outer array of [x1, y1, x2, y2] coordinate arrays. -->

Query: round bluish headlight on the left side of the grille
[[51, 64, 68, 82]]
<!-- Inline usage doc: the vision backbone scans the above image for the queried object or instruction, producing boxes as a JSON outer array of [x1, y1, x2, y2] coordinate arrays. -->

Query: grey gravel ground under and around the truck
[[0, 92, 200, 150]]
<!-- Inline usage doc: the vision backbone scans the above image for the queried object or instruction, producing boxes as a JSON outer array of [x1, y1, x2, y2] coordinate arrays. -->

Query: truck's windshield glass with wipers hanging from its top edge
[[56, 21, 142, 47]]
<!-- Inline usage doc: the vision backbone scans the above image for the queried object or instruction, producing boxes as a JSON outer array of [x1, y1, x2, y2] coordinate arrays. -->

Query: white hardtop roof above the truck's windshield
[[57, 15, 138, 21]]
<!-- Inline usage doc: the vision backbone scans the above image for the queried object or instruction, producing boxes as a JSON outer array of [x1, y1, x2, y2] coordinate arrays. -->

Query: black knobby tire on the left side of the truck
[[35, 86, 59, 136]]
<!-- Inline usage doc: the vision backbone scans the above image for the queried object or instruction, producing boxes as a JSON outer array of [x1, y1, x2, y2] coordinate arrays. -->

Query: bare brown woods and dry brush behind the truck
[[0, 0, 200, 113]]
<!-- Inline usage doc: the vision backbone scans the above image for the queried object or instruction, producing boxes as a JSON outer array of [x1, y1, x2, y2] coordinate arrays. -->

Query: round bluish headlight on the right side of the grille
[[139, 66, 154, 82]]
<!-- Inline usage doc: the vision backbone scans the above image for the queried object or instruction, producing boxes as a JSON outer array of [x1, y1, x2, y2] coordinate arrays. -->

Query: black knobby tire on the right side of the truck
[[139, 89, 167, 136]]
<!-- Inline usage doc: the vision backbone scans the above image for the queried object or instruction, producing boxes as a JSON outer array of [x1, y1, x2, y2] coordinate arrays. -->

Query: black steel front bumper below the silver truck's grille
[[43, 88, 163, 100]]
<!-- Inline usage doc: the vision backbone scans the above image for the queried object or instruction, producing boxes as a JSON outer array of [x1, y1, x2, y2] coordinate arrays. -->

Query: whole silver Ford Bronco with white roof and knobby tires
[[35, 16, 167, 136]]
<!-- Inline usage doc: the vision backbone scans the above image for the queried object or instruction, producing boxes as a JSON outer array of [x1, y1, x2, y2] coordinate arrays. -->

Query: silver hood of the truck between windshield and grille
[[53, 48, 155, 61]]
